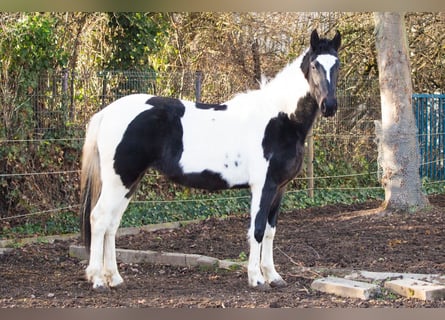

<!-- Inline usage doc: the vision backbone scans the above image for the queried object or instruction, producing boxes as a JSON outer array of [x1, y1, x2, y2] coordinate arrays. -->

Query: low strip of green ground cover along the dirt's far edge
[[0, 180, 445, 239]]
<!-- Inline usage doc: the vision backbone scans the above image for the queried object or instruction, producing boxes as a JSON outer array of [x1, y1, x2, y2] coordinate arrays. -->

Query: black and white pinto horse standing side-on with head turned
[[81, 30, 341, 289]]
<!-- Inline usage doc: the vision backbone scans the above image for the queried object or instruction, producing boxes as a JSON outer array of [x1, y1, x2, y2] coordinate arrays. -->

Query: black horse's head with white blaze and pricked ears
[[301, 30, 341, 117]]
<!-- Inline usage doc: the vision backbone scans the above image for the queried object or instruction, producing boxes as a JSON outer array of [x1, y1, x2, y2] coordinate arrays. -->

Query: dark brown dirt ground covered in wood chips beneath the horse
[[0, 195, 445, 308]]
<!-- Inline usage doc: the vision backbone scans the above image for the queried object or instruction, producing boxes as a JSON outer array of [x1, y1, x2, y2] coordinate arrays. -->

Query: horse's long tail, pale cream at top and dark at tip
[[80, 112, 102, 252]]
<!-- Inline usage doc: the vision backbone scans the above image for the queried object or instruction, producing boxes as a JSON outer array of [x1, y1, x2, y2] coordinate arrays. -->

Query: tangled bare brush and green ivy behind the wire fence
[[0, 12, 445, 235]]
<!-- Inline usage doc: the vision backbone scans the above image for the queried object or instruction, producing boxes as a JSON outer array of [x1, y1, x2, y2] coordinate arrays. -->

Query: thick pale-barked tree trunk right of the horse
[[374, 12, 428, 212]]
